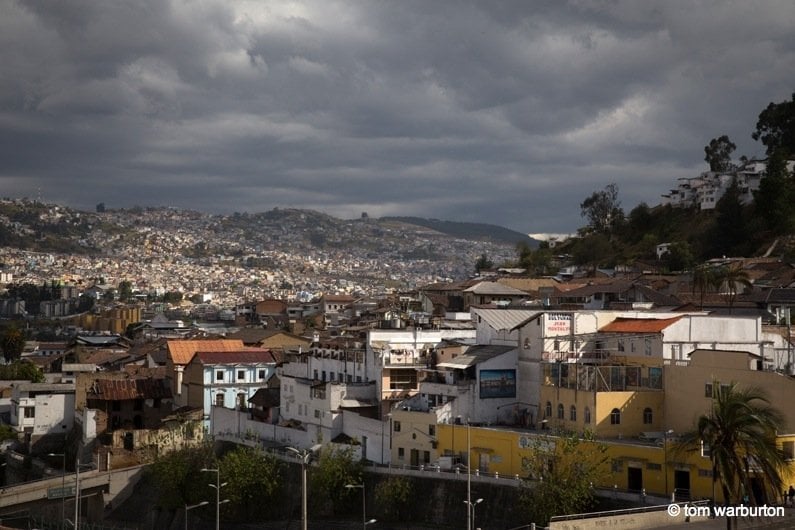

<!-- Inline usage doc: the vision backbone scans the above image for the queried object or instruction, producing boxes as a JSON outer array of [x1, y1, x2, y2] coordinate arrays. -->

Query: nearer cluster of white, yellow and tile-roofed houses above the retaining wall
[[0, 260, 795, 504]]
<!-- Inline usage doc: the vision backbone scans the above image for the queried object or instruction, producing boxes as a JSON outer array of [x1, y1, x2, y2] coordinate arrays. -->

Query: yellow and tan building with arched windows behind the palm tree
[[432, 344, 795, 502]]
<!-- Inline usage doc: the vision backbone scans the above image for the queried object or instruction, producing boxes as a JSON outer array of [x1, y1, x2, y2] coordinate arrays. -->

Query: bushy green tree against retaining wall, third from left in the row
[[309, 445, 363, 515]]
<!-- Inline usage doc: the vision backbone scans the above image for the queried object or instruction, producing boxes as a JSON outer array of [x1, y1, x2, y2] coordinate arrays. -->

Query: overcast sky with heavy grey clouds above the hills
[[0, 0, 795, 233]]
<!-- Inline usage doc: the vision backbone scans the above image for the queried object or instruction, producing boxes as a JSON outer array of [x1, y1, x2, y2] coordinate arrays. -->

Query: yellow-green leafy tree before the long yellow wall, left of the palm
[[521, 432, 607, 526]]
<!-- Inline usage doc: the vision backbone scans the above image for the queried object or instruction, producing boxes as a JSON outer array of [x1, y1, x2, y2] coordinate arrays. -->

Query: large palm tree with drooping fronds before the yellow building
[[678, 382, 786, 527]]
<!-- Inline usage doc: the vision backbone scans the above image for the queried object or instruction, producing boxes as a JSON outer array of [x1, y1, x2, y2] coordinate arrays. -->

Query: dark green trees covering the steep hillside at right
[[516, 94, 795, 275]]
